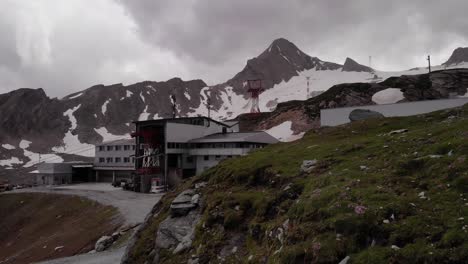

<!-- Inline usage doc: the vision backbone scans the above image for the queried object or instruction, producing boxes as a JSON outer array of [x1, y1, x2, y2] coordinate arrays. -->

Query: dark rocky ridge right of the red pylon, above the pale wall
[[252, 69, 468, 133]]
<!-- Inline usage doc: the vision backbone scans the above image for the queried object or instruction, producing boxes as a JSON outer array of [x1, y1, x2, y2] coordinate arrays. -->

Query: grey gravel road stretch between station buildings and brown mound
[[14, 183, 161, 225]]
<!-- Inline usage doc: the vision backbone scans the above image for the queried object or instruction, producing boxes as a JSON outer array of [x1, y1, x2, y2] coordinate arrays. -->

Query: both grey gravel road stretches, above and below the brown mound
[[13, 183, 162, 264]]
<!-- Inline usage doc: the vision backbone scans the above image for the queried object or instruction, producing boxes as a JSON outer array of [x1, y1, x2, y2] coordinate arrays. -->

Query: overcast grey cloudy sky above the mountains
[[0, 0, 468, 97]]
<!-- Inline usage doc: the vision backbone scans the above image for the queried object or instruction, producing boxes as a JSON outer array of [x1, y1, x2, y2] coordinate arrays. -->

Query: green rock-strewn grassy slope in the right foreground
[[133, 106, 468, 264]]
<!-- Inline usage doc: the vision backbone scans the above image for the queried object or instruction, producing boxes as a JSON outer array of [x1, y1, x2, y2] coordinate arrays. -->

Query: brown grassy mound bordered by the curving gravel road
[[0, 193, 121, 263]]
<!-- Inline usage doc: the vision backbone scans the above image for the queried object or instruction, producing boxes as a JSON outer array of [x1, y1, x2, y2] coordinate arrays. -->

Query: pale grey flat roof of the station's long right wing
[[189, 131, 279, 144]]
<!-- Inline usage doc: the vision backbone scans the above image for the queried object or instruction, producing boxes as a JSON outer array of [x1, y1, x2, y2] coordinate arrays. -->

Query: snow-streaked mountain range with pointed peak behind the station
[[0, 38, 465, 182]]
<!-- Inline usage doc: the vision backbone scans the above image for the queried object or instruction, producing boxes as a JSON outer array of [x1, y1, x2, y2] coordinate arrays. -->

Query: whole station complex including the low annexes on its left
[[35, 117, 278, 192]]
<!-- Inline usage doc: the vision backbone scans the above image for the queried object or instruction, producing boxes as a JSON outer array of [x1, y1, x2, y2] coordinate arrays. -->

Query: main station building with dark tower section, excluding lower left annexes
[[132, 117, 278, 192]]
